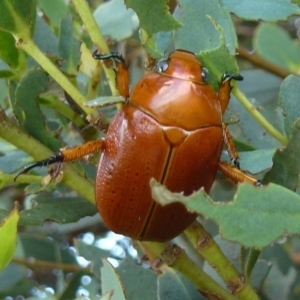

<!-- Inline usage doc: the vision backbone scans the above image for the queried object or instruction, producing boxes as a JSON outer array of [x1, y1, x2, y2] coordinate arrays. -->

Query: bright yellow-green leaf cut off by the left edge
[[0, 208, 19, 271]]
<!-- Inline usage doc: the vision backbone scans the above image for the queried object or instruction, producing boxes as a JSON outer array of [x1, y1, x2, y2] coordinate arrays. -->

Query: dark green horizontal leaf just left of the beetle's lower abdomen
[[19, 197, 97, 226]]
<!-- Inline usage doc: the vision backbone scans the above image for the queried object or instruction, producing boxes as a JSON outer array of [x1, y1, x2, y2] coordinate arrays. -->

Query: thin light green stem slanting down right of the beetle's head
[[233, 87, 288, 145]]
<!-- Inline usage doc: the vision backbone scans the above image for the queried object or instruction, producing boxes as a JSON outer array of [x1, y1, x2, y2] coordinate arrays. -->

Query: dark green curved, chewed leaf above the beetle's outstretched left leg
[[15, 69, 60, 151]]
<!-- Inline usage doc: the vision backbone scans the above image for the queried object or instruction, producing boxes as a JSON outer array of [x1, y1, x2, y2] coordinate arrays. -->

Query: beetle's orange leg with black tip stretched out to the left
[[14, 139, 104, 181]]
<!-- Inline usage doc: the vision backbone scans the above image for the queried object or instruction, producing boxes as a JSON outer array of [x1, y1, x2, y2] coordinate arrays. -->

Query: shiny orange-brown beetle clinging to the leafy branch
[[15, 50, 258, 242]]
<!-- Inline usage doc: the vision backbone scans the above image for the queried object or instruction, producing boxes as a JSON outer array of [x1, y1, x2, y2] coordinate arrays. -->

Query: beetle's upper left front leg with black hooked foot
[[93, 50, 129, 99]]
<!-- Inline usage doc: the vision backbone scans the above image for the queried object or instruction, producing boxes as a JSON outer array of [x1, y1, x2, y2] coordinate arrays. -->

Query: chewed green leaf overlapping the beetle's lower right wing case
[[151, 180, 300, 249]]
